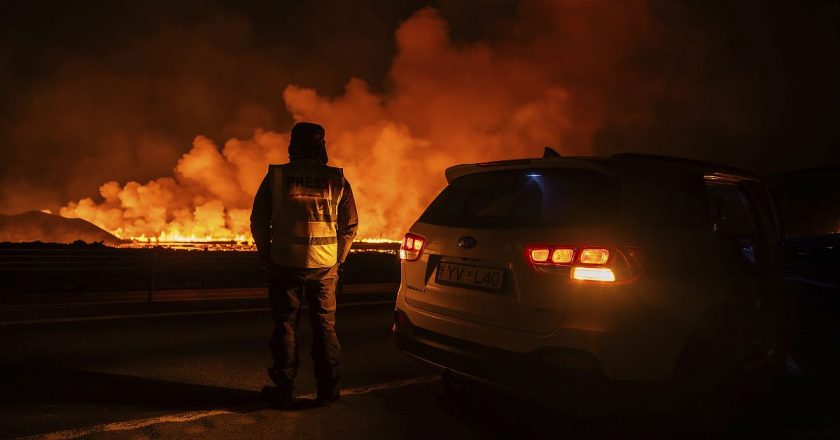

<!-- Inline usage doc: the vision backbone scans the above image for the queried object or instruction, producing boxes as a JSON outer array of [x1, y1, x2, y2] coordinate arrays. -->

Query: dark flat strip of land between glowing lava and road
[[0, 246, 399, 302]]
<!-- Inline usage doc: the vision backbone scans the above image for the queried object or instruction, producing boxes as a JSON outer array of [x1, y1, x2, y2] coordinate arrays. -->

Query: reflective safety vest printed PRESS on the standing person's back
[[271, 159, 344, 268]]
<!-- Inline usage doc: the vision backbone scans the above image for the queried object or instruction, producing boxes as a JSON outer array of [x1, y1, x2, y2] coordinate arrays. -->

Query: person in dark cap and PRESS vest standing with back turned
[[251, 122, 358, 408]]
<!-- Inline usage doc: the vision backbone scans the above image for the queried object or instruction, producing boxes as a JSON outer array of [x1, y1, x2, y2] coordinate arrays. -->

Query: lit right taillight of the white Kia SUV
[[525, 245, 644, 283]]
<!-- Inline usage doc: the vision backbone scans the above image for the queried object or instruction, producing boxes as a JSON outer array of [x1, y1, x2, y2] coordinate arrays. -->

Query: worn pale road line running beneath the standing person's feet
[[20, 374, 440, 440]]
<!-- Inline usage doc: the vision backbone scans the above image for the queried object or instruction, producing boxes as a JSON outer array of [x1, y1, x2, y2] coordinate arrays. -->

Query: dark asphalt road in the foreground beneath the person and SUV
[[0, 303, 838, 439]]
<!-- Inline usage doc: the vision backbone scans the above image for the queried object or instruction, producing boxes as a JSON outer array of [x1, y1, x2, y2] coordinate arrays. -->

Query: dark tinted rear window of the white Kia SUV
[[420, 168, 620, 228]]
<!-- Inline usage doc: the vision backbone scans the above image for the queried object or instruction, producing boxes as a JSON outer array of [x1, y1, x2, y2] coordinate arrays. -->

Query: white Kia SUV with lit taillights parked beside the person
[[393, 150, 783, 393]]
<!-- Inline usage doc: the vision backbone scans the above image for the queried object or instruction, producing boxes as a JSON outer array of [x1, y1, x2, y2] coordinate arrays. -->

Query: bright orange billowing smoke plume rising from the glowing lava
[[61, 1, 638, 241]]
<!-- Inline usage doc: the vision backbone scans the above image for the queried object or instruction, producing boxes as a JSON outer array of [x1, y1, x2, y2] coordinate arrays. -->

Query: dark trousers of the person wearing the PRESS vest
[[268, 265, 341, 387]]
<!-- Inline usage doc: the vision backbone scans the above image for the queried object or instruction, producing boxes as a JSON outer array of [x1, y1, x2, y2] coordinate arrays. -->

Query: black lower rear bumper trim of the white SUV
[[394, 311, 609, 395]]
